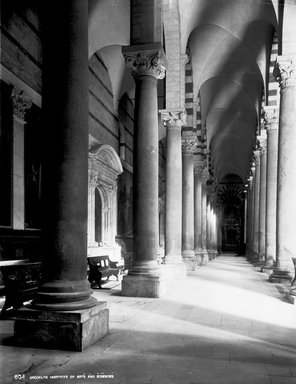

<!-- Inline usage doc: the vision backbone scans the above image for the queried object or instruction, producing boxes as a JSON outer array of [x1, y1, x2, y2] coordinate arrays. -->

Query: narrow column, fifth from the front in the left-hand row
[[194, 162, 204, 265]]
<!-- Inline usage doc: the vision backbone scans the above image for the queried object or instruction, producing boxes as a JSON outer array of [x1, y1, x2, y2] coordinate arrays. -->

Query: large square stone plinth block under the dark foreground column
[[8, 301, 109, 352]]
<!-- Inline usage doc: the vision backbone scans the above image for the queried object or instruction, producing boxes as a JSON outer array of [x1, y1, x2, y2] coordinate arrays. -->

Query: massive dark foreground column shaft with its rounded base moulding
[[34, 0, 96, 310]]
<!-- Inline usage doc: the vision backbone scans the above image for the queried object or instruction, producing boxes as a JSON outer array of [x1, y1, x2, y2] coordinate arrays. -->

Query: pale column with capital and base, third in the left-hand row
[[161, 110, 186, 278]]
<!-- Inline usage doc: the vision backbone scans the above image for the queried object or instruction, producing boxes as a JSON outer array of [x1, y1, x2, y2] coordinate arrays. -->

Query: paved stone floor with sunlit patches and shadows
[[0, 255, 296, 384]]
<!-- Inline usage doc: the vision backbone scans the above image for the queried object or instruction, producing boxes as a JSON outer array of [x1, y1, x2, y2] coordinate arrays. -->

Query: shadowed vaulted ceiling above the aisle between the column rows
[[179, 0, 277, 182]]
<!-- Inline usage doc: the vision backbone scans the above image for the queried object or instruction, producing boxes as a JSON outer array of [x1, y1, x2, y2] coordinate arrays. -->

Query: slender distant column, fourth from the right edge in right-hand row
[[253, 150, 260, 262]]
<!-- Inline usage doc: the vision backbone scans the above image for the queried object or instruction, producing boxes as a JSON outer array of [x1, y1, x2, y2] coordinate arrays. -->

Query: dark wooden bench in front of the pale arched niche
[[87, 255, 121, 288]]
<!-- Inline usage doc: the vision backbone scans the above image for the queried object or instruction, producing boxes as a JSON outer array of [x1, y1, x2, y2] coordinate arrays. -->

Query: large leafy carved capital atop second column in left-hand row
[[122, 44, 167, 79]]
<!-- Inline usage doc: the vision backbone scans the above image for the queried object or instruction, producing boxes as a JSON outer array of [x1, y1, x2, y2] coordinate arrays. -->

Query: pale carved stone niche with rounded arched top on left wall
[[88, 144, 123, 259]]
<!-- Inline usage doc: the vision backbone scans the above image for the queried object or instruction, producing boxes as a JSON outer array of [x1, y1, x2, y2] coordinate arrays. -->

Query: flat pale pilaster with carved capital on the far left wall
[[11, 87, 32, 229]]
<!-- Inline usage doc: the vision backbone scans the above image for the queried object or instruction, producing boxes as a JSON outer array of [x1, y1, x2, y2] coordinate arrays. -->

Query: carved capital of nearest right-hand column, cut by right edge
[[274, 56, 296, 89]]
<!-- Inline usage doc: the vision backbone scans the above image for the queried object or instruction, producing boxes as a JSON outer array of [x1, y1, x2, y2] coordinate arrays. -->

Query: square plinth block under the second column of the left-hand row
[[121, 274, 165, 297]]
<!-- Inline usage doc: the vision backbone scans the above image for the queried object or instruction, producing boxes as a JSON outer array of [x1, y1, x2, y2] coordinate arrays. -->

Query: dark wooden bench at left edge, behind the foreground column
[[0, 260, 41, 319]]
